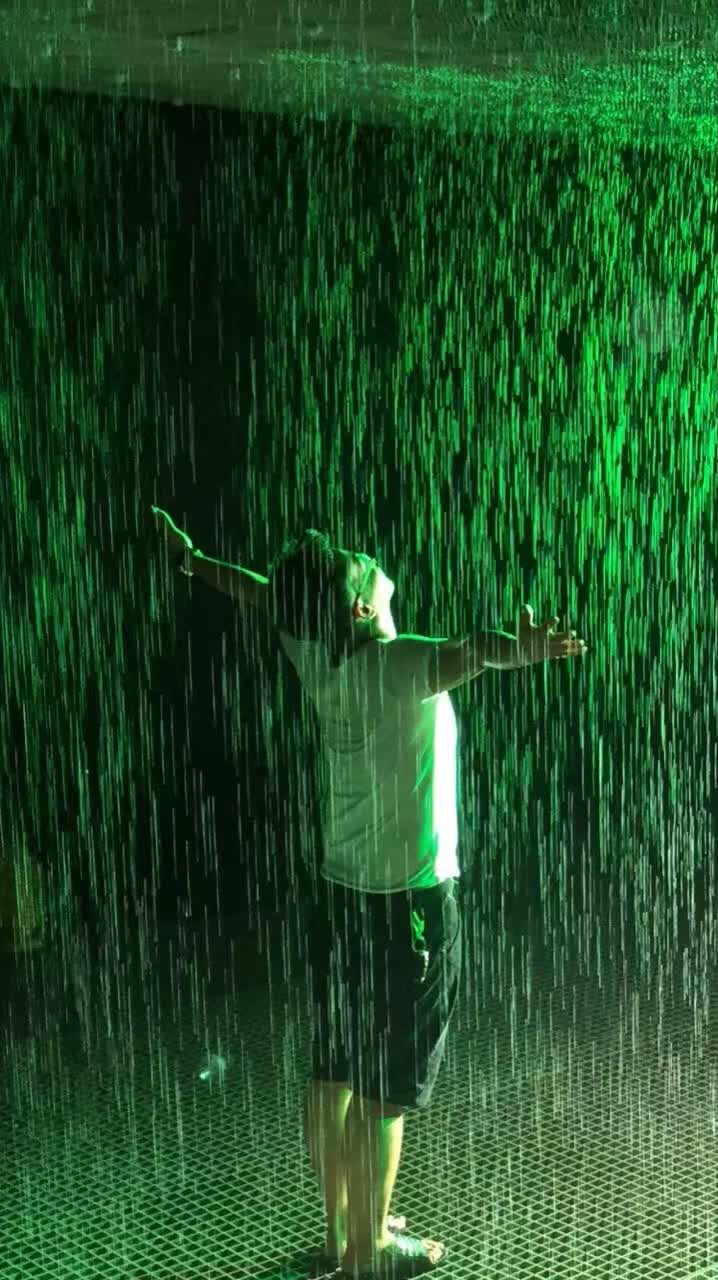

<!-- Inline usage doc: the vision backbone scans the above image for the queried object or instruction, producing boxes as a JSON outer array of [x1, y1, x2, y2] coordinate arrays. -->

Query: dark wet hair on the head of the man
[[269, 529, 353, 667]]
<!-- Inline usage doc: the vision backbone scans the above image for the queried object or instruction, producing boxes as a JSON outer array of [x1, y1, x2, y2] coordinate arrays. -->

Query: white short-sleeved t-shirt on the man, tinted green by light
[[279, 631, 459, 893]]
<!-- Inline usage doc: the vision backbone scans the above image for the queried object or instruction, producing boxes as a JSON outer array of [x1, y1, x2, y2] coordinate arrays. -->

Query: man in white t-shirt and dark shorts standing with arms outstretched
[[154, 508, 586, 1280]]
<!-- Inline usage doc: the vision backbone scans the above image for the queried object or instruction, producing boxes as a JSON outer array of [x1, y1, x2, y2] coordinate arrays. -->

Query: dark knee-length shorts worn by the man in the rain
[[300, 876, 462, 1110]]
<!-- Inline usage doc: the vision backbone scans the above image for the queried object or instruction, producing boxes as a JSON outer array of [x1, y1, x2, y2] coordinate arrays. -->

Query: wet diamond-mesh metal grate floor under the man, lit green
[[0, 905, 718, 1280]]
